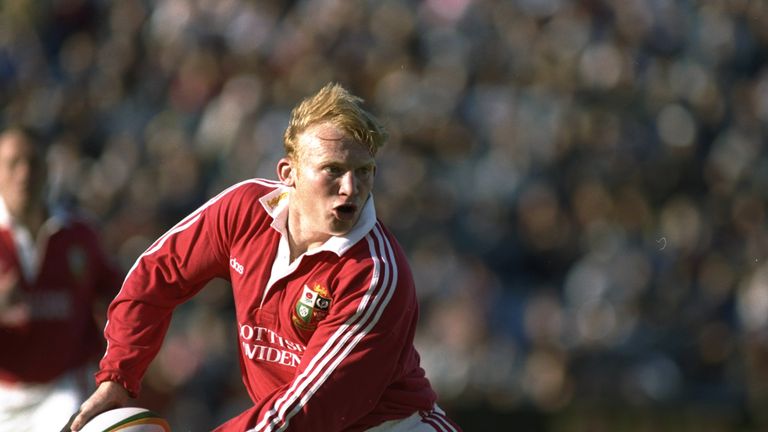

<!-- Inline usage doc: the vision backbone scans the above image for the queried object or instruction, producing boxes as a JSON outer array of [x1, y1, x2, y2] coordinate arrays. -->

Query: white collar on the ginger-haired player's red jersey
[[259, 186, 376, 256]]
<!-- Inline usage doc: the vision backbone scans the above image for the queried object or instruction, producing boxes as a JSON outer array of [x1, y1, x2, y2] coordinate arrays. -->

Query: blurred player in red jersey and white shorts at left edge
[[0, 127, 120, 432]]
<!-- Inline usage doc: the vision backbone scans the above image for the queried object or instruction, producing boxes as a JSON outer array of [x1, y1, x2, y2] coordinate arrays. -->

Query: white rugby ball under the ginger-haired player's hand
[[80, 407, 171, 432]]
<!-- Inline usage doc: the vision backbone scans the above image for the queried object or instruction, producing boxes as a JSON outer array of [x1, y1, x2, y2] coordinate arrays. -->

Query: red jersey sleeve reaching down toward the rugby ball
[[96, 187, 237, 396]]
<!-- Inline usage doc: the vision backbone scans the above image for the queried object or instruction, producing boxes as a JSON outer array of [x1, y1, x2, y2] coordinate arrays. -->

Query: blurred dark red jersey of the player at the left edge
[[0, 207, 120, 383]]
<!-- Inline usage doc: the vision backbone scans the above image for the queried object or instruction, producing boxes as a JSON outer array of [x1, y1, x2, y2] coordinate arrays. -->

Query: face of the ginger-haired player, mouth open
[[278, 123, 376, 242]]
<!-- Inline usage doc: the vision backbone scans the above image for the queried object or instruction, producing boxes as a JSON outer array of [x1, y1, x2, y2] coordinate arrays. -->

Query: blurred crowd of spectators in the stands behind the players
[[0, 0, 768, 432]]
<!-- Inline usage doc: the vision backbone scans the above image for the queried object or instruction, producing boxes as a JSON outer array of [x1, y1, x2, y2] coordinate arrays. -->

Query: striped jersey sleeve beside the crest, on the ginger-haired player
[[217, 226, 428, 432]]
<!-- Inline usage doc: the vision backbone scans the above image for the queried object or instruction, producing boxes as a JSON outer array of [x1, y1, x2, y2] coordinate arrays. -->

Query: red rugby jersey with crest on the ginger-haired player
[[97, 179, 436, 431]]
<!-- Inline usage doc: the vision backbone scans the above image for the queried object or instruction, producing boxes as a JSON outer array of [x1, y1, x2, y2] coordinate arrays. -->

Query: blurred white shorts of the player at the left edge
[[0, 369, 93, 432]]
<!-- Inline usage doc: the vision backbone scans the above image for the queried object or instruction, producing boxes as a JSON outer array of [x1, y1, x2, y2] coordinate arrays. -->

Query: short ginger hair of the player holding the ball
[[283, 83, 389, 158]]
